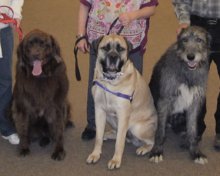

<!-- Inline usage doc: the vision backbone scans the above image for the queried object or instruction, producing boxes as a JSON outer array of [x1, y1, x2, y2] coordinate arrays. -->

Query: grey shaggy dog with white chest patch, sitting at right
[[149, 26, 210, 164]]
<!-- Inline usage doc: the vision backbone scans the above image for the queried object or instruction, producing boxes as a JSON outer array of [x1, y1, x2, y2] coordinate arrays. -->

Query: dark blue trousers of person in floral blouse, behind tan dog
[[87, 48, 143, 129]]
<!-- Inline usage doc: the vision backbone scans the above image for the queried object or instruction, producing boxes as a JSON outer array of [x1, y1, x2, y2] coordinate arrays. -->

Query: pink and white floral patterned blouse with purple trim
[[80, 0, 158, 50]]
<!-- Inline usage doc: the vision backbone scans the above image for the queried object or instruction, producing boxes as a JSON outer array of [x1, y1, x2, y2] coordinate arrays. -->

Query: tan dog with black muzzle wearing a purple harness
[[87, 34, 157, 169]]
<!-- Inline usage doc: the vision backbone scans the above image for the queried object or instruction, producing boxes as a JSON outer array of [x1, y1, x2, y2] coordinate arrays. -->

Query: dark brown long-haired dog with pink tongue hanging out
[[12, 30, 71, 160]]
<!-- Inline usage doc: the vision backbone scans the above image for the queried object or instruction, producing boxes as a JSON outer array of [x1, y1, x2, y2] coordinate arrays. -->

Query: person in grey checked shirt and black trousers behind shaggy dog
[[173, 0, 220, 151]]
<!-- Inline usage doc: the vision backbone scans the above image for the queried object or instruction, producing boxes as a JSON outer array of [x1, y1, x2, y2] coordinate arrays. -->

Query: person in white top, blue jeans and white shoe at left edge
[[0, 0, 24, 144]]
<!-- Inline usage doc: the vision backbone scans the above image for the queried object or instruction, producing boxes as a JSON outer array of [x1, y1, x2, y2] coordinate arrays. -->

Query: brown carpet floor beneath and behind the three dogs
[[0, 0, 220, 176]]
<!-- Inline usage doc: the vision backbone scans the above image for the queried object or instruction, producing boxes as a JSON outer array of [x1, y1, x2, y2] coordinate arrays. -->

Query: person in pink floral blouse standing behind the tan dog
[[77, 0, 158, 140]]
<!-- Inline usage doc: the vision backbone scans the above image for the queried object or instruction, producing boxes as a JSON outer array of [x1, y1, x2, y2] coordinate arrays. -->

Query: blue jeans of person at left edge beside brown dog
[[0, 27, 15, 136]]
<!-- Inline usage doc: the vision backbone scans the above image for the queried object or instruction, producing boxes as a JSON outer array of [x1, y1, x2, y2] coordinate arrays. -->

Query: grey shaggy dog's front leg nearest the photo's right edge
[[186, 102, 208, 164]]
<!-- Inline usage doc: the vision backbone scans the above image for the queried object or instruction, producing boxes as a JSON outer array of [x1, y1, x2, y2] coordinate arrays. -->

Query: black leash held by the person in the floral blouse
[[74, 17, 124, 81]]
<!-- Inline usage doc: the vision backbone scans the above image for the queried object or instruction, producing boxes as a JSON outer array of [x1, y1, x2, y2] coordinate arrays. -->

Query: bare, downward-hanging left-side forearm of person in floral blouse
[[77, 3, 89, 35]]
